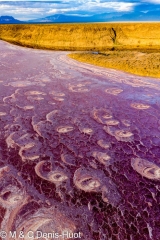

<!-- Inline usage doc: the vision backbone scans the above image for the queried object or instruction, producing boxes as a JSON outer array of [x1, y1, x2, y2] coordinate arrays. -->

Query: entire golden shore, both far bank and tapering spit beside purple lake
[[0, 22, 160, 78]]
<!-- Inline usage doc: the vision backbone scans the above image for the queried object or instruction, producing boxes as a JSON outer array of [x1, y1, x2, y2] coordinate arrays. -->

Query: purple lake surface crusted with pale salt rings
[[0, 41, 160, 240]]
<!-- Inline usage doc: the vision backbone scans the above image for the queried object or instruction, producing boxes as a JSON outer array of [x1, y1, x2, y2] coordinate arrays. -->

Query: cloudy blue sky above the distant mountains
[[0, 0, 160, 20]]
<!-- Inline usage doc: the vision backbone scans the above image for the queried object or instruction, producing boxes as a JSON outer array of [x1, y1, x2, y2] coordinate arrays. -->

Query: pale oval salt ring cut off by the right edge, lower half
[[131, 158, 160, 180]]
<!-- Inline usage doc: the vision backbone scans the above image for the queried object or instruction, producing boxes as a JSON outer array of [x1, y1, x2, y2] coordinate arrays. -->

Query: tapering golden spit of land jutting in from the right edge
[[69, 50, 160, 78]]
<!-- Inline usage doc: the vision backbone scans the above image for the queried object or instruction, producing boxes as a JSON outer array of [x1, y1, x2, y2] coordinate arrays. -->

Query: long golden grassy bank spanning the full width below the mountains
[[0, 23, 160, 51]]
